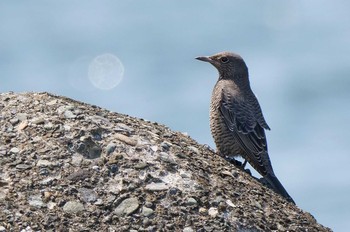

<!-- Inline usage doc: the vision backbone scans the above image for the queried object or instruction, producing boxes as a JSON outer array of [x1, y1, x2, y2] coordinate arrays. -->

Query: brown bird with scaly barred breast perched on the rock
[[196, 52, 295, 204]]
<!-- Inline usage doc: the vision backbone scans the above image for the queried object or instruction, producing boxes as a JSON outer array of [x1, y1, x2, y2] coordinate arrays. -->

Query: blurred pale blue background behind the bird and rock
[[0, 0, 350, 231]]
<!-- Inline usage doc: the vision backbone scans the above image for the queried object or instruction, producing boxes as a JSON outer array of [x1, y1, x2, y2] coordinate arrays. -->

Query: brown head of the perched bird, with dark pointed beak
[[196, 52, 248, 79]]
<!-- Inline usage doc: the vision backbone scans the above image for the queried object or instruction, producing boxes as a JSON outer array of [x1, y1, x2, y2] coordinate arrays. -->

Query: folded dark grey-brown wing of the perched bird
[[220, 91, 272, 175]]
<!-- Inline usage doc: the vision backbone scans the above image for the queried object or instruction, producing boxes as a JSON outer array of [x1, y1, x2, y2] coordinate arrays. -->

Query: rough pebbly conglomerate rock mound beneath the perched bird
[[0, 93, 330, 232]]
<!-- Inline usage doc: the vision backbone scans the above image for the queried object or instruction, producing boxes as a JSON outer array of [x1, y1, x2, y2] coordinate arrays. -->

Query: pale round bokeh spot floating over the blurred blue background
[[88, 54, 124, 90]]
